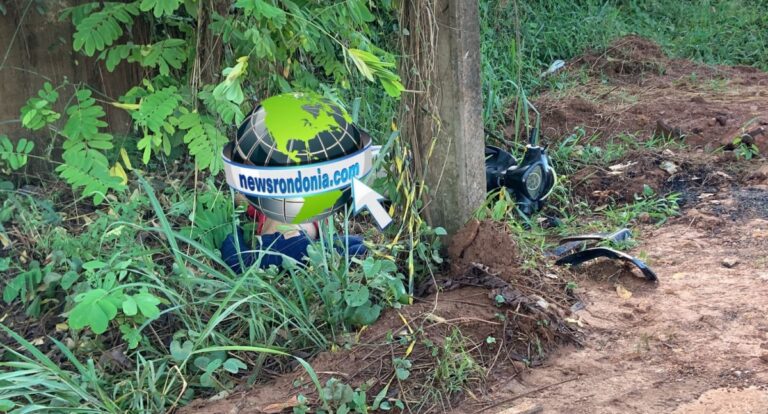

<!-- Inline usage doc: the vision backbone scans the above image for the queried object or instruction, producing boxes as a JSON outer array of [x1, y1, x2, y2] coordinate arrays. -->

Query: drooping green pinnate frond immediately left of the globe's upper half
[[179, 111, 227, 174]]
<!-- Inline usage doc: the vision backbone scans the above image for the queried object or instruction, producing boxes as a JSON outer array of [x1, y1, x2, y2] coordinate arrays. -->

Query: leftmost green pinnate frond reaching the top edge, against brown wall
[[72, 3, 139, 56]]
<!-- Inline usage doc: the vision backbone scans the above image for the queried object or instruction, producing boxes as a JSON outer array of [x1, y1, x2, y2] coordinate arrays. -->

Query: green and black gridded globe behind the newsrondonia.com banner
[[231, 93, 365, 223]]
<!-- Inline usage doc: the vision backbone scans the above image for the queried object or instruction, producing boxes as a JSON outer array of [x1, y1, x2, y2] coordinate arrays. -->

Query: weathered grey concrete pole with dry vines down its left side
[[403, 0, 486, 238]]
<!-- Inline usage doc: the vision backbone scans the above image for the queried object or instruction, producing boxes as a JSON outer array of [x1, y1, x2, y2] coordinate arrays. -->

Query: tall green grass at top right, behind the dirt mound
[[480, 0, 768, 128]]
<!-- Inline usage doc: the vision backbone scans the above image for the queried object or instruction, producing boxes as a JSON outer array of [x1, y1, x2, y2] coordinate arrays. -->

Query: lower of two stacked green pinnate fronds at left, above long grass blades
[[56, 145, 125, 204]]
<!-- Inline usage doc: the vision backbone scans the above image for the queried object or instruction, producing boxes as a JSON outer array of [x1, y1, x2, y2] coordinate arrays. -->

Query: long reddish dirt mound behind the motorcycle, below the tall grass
[[535, 36, 768, 153]]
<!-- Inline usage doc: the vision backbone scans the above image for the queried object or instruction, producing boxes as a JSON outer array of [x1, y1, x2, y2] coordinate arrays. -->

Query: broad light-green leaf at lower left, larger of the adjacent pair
[[68, 289, 119, 334]]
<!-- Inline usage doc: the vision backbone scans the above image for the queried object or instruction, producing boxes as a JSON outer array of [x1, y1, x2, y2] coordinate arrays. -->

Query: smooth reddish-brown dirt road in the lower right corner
[[484, 186, 768, 414]]
